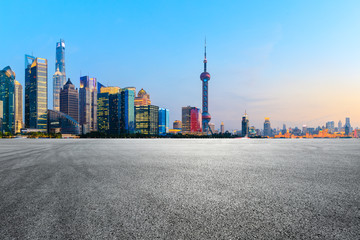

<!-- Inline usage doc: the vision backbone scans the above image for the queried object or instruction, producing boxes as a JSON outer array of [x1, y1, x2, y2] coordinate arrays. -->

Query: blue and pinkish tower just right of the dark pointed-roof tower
[[79, 76, 97, 134]]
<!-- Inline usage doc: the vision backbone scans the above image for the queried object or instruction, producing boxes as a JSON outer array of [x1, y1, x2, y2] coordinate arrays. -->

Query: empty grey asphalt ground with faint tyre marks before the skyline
[[0, 139, 360, 239]]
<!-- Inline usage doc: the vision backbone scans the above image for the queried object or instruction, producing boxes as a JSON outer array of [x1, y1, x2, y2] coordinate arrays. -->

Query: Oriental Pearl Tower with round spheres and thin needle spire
[[200, 39, 211, 134]]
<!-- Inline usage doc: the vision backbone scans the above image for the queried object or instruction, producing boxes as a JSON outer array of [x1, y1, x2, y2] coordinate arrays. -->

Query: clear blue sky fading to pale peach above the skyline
[[0, 0, 360, 129]]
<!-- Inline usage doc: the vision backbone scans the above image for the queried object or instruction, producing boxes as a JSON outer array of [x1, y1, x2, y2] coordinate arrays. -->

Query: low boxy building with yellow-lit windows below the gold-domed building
[[135, 105, 159, 135]]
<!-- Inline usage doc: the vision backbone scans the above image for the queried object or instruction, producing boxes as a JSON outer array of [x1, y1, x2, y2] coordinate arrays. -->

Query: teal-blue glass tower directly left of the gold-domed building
[[121, 88, 135, 133]]
